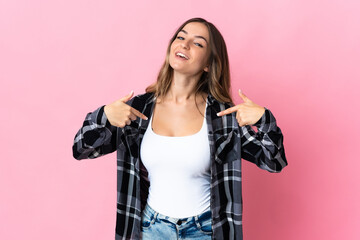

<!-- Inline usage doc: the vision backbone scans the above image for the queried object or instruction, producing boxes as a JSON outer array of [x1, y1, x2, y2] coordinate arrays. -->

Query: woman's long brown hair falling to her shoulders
[[145, 18, 233, 104]]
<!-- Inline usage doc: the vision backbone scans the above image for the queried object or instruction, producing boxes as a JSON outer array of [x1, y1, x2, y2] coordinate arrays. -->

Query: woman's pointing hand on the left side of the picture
[[104, 91, 148, 128]]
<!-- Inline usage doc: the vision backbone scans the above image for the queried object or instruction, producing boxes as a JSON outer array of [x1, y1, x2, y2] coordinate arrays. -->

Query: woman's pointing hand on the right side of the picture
[[217, 89, 265, 127]]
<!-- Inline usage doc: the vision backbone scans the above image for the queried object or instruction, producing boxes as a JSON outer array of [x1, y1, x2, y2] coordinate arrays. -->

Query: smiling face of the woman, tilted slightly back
[[169, 22, 210, 76]]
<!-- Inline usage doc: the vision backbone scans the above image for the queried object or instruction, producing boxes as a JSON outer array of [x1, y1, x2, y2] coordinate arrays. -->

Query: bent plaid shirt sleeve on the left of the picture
[[72, 105, 118, 160]]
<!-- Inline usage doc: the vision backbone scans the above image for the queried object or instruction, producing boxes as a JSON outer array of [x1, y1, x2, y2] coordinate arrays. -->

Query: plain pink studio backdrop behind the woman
[[0, 0, 360, 240]]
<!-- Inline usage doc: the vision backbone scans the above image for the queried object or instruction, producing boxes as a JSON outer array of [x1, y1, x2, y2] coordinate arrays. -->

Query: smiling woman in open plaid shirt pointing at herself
[[73, 18, 288, 240]]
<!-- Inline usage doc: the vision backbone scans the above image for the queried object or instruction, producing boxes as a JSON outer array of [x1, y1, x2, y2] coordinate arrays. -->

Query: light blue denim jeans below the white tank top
[[141, 204, 212, 240]]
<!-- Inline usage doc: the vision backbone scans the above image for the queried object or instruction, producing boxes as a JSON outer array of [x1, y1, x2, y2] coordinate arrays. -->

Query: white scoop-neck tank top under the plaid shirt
[[140, 104, 210, 218]]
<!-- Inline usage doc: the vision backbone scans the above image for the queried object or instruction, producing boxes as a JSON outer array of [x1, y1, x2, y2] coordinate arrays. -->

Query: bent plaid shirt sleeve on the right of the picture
[[239, 107, 288, 173]]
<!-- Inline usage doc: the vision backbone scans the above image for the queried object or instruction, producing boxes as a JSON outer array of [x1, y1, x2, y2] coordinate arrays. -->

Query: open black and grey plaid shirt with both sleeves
[[73, 93, 288, 240]]
